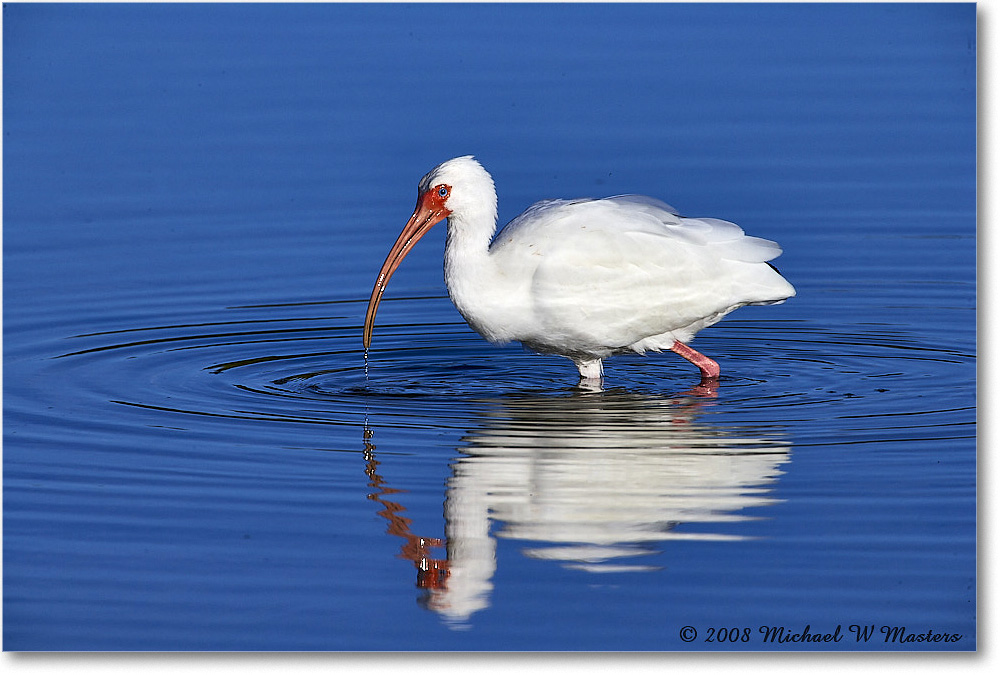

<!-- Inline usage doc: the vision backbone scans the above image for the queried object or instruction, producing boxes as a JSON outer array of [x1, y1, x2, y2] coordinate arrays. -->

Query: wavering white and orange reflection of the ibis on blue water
[[365, 390, 789, 625]]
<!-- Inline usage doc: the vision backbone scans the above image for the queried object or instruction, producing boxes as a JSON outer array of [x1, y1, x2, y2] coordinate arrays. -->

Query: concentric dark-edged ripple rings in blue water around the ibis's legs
[[1, 290, 974, 454]]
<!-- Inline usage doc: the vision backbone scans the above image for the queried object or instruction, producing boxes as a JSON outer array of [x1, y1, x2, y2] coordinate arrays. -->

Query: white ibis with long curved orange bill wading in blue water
[[364, 155, 795, 380]]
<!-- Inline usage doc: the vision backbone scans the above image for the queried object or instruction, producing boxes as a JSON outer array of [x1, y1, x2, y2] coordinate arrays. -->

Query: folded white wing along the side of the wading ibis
[[522, 197, 787, 350]]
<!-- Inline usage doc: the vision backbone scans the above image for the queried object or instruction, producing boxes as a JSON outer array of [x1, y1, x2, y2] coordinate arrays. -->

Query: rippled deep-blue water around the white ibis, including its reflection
[[3, 4, 977, 651]]
